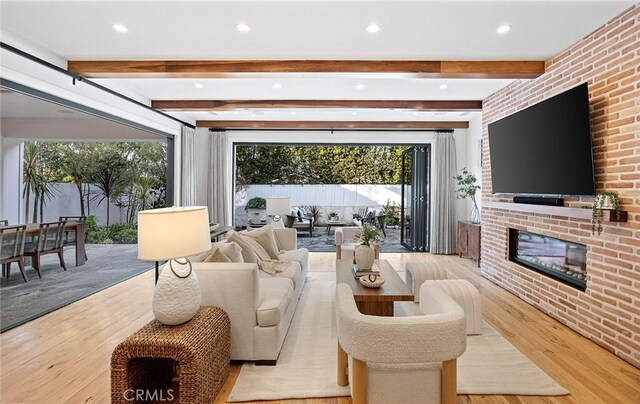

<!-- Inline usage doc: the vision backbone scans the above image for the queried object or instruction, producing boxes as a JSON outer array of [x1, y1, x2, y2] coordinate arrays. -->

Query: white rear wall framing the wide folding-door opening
[[192, 129, 468, 223]]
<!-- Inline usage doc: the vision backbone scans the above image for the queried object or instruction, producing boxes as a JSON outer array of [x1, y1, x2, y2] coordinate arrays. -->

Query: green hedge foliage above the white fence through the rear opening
[[236, 145, 405, 186]]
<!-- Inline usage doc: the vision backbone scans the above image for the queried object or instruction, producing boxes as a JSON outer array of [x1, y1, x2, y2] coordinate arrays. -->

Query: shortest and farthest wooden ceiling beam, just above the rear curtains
[[196, 121, 469, 129]]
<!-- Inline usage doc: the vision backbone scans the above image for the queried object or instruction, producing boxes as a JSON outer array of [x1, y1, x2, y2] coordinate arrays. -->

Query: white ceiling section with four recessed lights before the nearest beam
[[0, 0, 634, 60]]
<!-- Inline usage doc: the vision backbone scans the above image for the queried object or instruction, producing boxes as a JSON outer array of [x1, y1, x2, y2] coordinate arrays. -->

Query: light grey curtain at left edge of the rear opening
[[207, 130, 230, 225]]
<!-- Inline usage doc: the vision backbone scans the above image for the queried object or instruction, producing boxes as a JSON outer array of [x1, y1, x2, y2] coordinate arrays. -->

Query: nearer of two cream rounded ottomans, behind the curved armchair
[[420, 279, 482, 335]]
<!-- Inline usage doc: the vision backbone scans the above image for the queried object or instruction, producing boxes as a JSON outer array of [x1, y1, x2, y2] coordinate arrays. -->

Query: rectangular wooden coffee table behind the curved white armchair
[[336, 259, 413, 317]]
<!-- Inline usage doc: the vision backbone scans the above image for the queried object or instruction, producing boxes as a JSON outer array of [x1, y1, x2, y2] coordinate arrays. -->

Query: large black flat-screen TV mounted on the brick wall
[[488, 83, 595, 195]]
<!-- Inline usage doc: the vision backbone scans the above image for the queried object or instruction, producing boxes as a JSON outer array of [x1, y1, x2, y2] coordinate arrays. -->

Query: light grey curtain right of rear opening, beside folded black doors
[[429, 132, 457, 254]]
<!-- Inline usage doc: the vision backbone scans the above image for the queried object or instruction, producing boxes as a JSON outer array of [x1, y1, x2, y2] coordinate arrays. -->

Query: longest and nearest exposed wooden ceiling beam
[[68, 60, 545, 79]]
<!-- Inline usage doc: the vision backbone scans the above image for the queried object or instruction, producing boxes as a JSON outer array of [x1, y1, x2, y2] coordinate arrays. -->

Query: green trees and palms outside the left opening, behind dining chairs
[[23, 142, 167, 225]]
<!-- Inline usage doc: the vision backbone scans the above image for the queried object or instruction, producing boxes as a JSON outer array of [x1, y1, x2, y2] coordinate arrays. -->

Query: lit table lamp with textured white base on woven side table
[[138, 206, 211, 325]]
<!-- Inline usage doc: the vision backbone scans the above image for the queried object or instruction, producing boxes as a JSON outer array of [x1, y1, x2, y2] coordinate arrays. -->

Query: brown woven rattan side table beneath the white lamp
[[111, 307, 231, 404]]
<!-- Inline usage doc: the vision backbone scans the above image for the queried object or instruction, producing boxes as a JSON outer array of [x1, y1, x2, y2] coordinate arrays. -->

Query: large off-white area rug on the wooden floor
[[228, 272, 569, 402]]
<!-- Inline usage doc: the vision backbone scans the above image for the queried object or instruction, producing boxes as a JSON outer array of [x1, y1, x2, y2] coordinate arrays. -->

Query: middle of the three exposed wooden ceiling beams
[[151, 100, 482, 111]]
